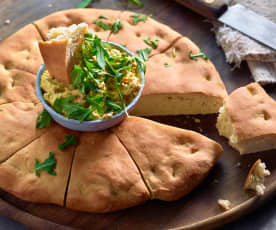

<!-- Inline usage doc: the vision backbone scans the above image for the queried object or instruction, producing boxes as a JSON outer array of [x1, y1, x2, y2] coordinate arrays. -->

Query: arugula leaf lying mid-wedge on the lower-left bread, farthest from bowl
[[35, 152, 57, 177]]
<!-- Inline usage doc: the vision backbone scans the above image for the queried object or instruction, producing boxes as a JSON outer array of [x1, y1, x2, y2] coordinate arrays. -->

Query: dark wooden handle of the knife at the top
[[176, 0, 227, 20]]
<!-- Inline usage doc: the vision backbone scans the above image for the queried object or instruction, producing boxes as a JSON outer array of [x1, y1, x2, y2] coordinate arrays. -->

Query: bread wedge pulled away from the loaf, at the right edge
[[216, 83, 276, 154]]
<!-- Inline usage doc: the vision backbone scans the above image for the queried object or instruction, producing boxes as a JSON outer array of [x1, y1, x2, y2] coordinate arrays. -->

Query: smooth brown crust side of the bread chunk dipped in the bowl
[[39, 40, 72, 84]]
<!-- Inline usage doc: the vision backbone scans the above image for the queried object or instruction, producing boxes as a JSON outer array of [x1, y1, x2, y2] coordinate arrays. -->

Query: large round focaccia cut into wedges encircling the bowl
[[0, 9, 224, 212]]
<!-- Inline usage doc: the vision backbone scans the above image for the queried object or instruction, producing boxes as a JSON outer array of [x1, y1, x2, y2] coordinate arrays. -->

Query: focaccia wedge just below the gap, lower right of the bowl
[[113, 117, 222, 201]]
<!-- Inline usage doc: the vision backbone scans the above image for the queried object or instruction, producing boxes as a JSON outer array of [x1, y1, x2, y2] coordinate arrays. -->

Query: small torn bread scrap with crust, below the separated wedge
[[244, 159, 270, 196]]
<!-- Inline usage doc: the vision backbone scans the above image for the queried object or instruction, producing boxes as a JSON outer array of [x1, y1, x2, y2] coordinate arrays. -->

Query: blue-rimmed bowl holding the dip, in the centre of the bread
[[35, 42, 145, 132]]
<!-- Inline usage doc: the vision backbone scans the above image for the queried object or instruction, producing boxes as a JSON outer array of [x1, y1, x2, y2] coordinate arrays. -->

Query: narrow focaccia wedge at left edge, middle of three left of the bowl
[[0, 65, 39, 105]]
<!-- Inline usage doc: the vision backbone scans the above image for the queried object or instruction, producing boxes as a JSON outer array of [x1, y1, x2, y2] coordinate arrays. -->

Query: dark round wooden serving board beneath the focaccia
[[0, 0, 276, 230]]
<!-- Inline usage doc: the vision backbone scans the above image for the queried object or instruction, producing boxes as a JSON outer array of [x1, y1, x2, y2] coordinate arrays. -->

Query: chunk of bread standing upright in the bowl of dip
[[39, 23, 88, 84]]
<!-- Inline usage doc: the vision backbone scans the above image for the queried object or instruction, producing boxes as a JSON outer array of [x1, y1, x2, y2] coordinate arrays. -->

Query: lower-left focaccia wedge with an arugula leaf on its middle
[[0, 125, 75, 205]]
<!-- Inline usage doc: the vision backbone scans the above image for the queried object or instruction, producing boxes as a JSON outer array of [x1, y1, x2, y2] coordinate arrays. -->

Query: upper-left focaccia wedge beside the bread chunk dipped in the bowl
[[0, 24, 42, 74]]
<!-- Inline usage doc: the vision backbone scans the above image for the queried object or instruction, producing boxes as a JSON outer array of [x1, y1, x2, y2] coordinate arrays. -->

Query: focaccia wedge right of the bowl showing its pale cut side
[[132, 37, 227, 116]]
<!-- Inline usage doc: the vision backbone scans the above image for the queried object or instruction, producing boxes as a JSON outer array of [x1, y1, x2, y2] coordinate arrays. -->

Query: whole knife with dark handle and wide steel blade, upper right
[[176, 0, 276, 50]]
